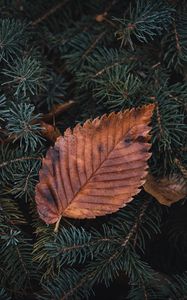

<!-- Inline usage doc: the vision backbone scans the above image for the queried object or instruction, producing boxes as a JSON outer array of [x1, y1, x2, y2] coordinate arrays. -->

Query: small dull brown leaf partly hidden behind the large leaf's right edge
[[143, 174, 187, 206]]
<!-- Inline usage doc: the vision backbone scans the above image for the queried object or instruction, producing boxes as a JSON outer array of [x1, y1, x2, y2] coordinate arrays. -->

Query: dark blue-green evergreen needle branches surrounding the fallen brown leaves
[[0, 0, 187, 300]]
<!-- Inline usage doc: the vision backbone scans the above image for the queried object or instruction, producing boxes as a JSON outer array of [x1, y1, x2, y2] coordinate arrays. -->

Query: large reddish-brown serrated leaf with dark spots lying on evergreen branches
[[36, 104, 154, 224]]
